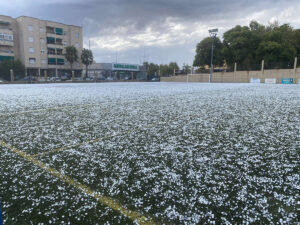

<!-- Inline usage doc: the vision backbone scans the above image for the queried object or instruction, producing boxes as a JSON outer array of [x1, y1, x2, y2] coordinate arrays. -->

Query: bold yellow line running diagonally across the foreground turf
[[0, 140, 155, 225]]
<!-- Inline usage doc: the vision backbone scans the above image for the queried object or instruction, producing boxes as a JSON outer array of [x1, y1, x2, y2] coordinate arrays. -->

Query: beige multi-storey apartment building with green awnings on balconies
[[0, 16, 83, 76]]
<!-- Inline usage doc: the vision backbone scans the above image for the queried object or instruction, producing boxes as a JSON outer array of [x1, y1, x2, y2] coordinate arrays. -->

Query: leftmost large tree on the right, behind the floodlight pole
[[193, 37, 223, 67]]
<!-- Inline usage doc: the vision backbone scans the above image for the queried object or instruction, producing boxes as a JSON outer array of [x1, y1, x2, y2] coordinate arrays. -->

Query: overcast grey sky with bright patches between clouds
[[0, 0, 300, 66]]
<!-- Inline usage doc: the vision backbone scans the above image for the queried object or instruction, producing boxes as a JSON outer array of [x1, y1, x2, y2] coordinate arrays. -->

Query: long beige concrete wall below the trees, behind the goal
[[160, 69, 300, 83]]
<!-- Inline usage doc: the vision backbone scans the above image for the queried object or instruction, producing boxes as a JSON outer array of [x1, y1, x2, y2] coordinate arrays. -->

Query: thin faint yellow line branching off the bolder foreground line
[[30, 123, 159, 157]]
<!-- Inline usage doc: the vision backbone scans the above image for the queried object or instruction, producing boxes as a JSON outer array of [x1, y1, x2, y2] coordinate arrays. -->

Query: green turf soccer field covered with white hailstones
[[0, 83, 300, 225]]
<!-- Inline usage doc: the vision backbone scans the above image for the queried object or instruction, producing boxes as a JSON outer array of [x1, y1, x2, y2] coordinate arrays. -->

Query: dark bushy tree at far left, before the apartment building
[[0, 60, 25, 81]]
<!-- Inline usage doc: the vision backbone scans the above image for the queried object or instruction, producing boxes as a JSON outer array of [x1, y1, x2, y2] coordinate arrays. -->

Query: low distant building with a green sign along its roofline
[[84, 63, 147, 80]]
